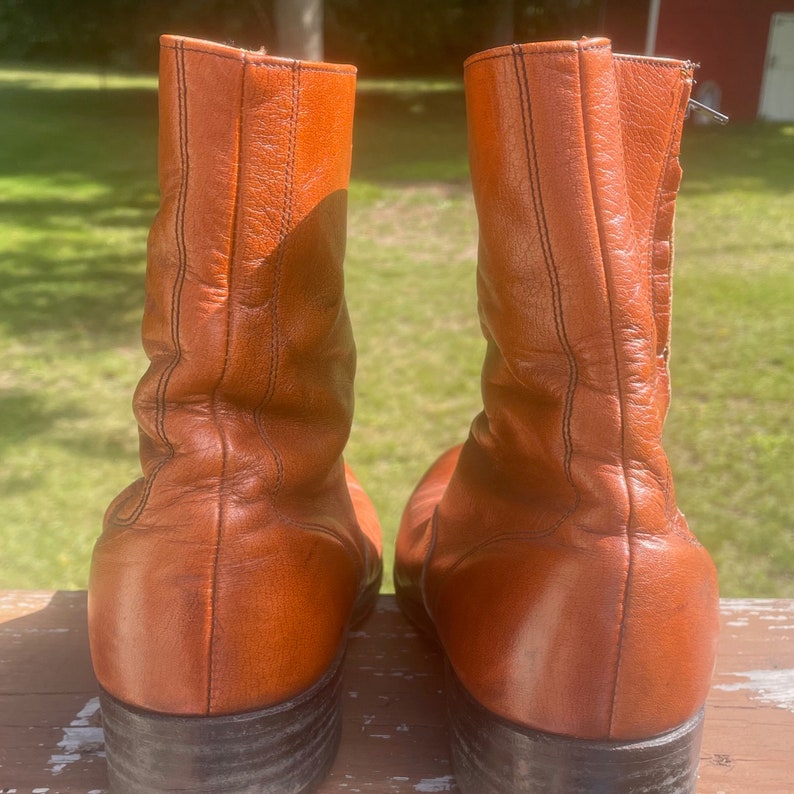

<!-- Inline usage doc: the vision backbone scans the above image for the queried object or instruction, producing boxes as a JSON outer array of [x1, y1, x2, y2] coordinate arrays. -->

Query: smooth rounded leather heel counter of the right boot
[[426, 528, 719, 740]]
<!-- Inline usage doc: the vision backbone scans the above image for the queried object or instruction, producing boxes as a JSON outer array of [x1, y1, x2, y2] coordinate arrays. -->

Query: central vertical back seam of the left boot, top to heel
[[207, 53, 247, 715]]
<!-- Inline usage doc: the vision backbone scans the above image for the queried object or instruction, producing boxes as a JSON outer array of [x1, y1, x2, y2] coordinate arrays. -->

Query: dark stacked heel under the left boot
[[100, 664, 342, 794]]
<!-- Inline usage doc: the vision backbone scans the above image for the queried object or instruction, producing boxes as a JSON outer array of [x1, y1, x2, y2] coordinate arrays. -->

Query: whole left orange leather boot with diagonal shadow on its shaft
[[89, 36, 381, 794]]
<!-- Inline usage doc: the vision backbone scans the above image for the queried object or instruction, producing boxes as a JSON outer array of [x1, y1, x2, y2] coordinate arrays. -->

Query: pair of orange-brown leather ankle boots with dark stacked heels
[[89, 36, 717, 794]]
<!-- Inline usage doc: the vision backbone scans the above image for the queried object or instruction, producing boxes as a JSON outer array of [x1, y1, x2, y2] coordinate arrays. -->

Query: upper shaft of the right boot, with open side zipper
[[453, 40, 692, 533]]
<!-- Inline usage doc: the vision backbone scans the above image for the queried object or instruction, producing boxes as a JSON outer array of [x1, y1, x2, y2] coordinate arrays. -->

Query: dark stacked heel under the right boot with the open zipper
[[447, 669, 703, 794]]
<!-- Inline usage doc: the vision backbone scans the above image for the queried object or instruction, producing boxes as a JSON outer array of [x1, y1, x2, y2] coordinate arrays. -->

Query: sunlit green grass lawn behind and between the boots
[[0, 69, 794, 597]]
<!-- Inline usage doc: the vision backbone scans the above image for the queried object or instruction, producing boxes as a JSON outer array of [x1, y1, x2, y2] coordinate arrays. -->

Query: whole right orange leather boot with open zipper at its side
[[395, 39, 718, 794]]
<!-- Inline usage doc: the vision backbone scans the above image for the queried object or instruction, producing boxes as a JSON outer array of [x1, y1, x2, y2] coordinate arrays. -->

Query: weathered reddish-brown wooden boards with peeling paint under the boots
[[0, 592, 794, 794]]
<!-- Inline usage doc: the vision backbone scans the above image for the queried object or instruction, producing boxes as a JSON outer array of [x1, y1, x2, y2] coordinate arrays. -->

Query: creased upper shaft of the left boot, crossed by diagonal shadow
[[134, 37, 355, 510]]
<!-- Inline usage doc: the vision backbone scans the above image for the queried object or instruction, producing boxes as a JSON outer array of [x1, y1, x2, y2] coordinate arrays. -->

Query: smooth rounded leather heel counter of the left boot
[[89, 508, 361, 716]]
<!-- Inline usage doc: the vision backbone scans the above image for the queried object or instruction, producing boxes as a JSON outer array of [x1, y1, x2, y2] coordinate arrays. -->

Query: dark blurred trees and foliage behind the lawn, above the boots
[[0, 0, 605, 77]]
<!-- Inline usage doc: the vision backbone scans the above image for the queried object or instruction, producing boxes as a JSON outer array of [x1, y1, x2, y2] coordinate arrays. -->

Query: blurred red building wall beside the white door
[[604, 0, 794, 120]]
